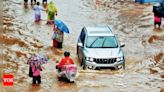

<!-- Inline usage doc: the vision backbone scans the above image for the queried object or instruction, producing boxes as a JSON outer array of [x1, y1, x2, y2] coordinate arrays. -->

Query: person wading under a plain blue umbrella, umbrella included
[[53, 20, 69, 48]]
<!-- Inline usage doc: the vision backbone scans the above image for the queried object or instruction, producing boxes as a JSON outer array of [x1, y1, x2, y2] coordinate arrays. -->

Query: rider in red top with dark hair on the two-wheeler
[[57, 51, 74, 69]]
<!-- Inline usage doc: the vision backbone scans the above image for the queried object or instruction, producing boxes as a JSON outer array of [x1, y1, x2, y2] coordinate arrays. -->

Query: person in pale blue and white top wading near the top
[[33, 2, 43, 22]]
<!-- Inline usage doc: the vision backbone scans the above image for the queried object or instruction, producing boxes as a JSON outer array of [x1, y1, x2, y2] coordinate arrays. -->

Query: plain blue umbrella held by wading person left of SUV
[[54, 20, 69, 33]]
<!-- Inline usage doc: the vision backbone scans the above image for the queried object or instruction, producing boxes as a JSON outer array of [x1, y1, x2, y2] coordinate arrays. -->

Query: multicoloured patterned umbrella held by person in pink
[[27, 54, 48, 66]]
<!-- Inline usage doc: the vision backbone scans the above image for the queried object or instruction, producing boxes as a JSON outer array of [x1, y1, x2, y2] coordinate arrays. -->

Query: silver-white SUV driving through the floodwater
[[77, 26, 125, 69]]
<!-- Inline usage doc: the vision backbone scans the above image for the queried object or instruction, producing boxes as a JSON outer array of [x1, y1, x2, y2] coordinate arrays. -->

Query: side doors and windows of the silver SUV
[[77, 28, 86, 62]]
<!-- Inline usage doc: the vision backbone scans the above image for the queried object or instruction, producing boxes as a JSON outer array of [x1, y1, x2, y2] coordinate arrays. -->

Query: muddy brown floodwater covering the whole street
[[0, 0, 164, 92]]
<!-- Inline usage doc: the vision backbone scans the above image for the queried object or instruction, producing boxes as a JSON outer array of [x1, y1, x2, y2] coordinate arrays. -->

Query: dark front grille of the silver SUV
[[94, 58, 116, 64]]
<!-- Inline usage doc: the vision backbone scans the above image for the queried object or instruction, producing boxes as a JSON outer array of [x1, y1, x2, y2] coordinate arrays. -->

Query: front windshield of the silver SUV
[[86, 36, 118, 48]]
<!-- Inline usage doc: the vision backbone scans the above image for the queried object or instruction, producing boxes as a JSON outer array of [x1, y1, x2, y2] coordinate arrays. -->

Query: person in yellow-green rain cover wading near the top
[[47, 1, 58, 24]]
